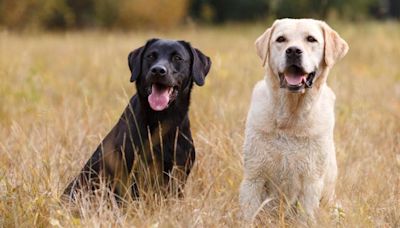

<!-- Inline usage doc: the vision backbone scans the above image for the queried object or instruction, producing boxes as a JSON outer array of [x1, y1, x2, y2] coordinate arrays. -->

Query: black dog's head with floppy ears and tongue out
[[128, 39, 211, 111]]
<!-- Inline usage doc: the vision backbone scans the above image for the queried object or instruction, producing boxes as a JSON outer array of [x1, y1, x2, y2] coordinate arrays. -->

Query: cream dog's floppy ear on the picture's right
[[321, 22, 349, 66]]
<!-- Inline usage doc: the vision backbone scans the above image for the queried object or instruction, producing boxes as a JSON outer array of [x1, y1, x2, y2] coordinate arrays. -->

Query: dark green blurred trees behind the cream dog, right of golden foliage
[[191, 0, 400, 22]]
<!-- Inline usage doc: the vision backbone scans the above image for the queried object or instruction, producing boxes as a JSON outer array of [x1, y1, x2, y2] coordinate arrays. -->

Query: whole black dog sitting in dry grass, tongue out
[[64, 39, 211, 199]]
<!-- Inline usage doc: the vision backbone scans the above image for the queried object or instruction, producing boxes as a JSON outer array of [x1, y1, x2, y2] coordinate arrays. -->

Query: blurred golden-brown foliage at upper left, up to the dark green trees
[[0, 0, 189, 29]]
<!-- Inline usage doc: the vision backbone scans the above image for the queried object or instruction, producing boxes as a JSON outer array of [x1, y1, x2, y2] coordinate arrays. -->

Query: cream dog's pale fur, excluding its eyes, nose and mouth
[[240, 19, 348, 221]]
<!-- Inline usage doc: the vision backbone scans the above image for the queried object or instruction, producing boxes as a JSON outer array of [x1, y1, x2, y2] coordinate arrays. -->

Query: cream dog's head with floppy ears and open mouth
[[255, 19, 349, 93]]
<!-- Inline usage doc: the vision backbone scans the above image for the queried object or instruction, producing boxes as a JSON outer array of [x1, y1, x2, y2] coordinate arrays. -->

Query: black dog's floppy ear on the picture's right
[[179, 41, 211, 86]]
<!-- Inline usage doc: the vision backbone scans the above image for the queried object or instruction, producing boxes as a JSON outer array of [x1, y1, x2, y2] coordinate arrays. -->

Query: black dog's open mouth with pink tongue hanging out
[[147, 83, 178, 111]]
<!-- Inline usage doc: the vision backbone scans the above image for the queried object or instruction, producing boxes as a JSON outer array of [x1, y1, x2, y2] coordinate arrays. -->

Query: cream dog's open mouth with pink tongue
[[279, 65, 315, 93]]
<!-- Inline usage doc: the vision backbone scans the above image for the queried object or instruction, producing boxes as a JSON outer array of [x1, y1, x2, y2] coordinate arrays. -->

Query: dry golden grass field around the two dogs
[[0, 23, 400, 227]]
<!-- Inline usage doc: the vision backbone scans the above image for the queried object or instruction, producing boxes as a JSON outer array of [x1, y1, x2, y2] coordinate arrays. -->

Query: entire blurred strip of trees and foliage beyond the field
[[0, 0, 400, 30]]
